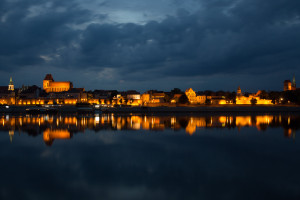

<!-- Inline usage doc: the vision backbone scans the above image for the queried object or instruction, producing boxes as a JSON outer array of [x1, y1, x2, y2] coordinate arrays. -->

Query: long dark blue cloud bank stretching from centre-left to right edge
[[77, 1, 300, 76]]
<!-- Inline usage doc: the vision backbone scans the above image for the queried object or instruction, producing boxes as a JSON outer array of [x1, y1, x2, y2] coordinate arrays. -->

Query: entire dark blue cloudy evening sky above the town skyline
[[0, 0, 300, 92]]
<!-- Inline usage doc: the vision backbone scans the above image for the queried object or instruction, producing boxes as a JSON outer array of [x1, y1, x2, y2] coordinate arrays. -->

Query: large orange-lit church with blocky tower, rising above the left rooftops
[[43, 74, 73, 93]]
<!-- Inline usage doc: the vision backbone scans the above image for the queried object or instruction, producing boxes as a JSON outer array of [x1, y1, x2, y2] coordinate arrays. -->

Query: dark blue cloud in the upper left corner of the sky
[[0, 1, 89, 71]]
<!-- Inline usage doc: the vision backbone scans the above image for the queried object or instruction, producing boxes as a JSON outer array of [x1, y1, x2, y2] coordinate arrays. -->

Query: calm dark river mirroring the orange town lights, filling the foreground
[[0, 114, 300, 200]]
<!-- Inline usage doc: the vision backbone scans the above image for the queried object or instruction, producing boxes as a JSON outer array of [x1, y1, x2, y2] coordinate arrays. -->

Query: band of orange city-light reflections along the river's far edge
[[0, 114, 300, 145]]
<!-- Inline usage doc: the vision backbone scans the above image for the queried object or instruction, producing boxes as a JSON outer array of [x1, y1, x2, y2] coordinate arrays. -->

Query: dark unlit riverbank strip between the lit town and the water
[[0, 105, 300, 113]]
